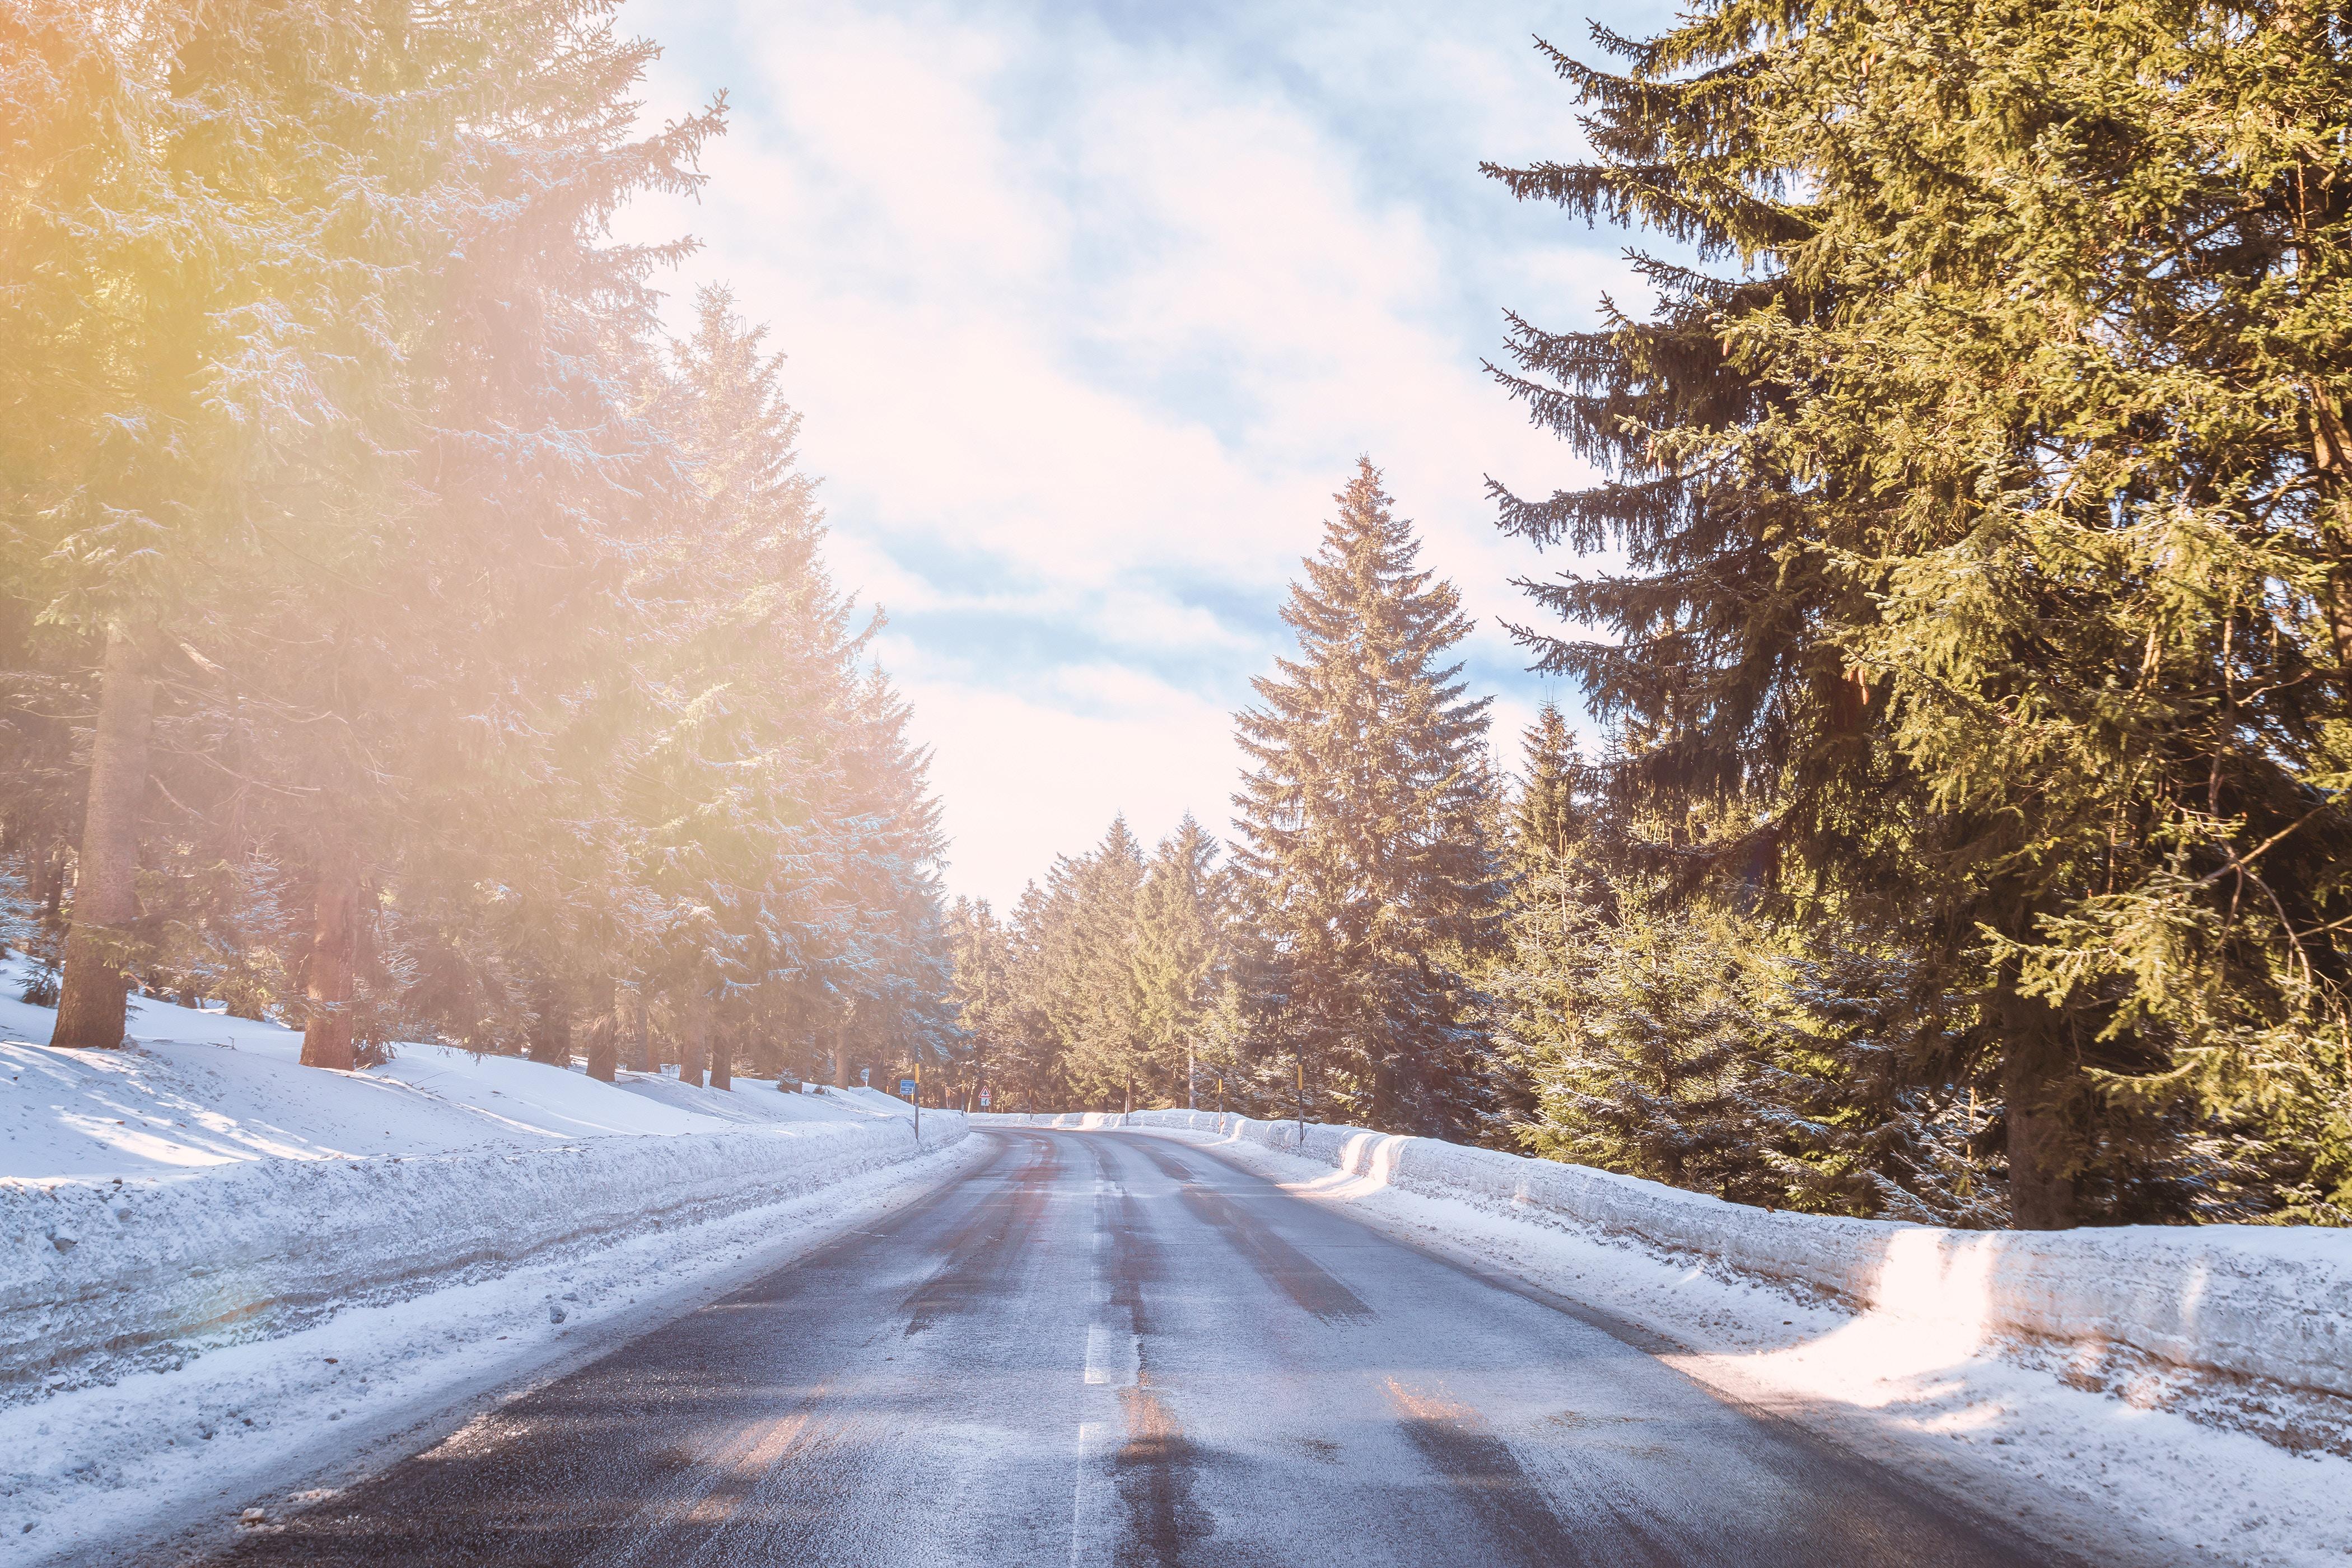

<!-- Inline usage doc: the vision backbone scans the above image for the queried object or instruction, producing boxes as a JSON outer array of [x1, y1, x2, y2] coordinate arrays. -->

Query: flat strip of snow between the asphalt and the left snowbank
[[0, 1133, 986, 1568]]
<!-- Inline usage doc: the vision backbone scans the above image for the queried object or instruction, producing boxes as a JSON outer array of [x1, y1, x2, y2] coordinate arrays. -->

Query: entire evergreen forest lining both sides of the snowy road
[[0, 0, 2352, 1230]]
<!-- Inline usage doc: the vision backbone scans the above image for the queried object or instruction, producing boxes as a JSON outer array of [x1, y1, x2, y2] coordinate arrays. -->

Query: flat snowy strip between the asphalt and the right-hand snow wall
[[1138, 1128, 2352, 1568]]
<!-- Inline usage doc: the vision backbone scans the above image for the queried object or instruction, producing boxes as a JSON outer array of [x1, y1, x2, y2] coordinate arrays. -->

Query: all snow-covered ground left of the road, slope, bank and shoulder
[[0, 959, 978, 1564]]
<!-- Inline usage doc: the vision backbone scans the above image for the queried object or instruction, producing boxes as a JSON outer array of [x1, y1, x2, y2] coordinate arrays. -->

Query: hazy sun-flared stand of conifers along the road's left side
[[0, 0, 953, 1081]]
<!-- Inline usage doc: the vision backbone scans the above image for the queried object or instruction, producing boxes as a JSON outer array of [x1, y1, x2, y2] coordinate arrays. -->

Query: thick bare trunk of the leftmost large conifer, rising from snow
[[49, 632, 155, 1048]]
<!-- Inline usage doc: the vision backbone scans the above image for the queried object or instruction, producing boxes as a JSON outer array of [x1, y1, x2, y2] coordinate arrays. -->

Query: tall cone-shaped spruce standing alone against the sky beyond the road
[[1235, 459, 1498, 1138]]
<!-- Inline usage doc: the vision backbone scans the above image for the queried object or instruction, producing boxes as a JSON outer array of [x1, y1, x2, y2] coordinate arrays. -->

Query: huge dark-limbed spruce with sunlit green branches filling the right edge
[[1494, 0, 2352, 1227]]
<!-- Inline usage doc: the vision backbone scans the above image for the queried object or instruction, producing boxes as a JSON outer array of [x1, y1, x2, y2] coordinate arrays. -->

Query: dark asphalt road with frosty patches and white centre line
[[216, 1131, 2054, 1568]]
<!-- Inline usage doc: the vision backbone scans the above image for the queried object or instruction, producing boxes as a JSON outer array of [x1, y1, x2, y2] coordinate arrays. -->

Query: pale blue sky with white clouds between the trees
[[619, 0, 1668, 907]]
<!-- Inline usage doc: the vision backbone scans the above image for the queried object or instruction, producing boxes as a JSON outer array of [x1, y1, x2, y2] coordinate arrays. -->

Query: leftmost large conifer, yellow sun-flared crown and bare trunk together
[[4, 0, 430, 1046]]
